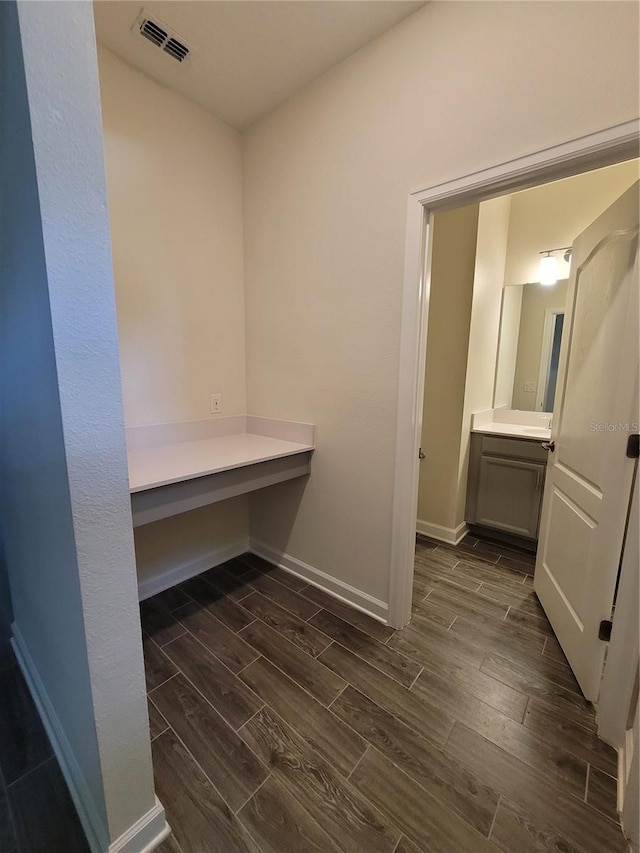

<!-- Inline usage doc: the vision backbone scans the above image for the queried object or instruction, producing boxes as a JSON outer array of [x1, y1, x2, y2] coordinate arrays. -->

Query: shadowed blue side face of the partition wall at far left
[[0, 3, 106, 840]]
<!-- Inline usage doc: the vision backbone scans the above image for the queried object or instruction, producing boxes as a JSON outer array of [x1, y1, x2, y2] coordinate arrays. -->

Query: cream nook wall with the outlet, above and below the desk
[[98, 47, 249, 589]]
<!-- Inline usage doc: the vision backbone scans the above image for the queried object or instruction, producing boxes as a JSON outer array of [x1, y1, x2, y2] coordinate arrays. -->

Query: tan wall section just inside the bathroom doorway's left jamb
[[416, 204, 479, 537]]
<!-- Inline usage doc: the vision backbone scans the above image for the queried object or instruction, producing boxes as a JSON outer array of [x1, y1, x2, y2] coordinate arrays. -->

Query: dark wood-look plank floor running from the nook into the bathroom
[[141, 539, 626, 853]]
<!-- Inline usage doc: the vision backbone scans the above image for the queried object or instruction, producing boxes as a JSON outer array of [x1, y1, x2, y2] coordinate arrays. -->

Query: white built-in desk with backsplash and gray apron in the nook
[[126, 415, 315, 527]]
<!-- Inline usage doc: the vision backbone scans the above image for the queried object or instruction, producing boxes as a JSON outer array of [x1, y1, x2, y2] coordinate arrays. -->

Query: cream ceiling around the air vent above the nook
[[93, 0, 425, 129]]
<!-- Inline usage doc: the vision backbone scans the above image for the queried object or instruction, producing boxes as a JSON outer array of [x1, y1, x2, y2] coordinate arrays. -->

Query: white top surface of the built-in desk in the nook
[[128, 433, 314, 492]]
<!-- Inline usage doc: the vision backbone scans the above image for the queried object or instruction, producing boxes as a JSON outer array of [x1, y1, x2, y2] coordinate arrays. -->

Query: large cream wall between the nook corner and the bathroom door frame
[[245, 2, 640, 600]]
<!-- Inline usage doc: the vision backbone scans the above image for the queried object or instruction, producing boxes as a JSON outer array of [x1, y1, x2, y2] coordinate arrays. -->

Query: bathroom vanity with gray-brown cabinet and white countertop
[[466, 410, 551, 550]]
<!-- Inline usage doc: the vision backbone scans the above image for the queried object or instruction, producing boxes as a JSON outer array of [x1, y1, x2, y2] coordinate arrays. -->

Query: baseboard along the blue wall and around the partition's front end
[[11, 622, 171, 853]]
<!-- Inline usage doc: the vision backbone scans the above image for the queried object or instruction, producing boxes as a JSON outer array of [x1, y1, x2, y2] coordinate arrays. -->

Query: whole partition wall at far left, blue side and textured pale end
[[0, 2, 160, 850]]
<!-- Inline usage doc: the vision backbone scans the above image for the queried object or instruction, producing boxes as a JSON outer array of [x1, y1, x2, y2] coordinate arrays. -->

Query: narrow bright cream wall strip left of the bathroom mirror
[[455, 196, 511, 526]]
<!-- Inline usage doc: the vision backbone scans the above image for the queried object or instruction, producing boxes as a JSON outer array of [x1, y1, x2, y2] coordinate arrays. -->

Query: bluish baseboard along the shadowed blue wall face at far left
[[11, 622, 109, 853]]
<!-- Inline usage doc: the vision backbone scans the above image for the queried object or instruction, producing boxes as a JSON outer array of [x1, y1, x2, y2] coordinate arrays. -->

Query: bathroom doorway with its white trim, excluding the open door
[[390, 120, 637, 700]]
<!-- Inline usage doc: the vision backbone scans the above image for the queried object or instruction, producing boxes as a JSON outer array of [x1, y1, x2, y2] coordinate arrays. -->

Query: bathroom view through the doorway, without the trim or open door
[[402, 155, 638, 620]]
